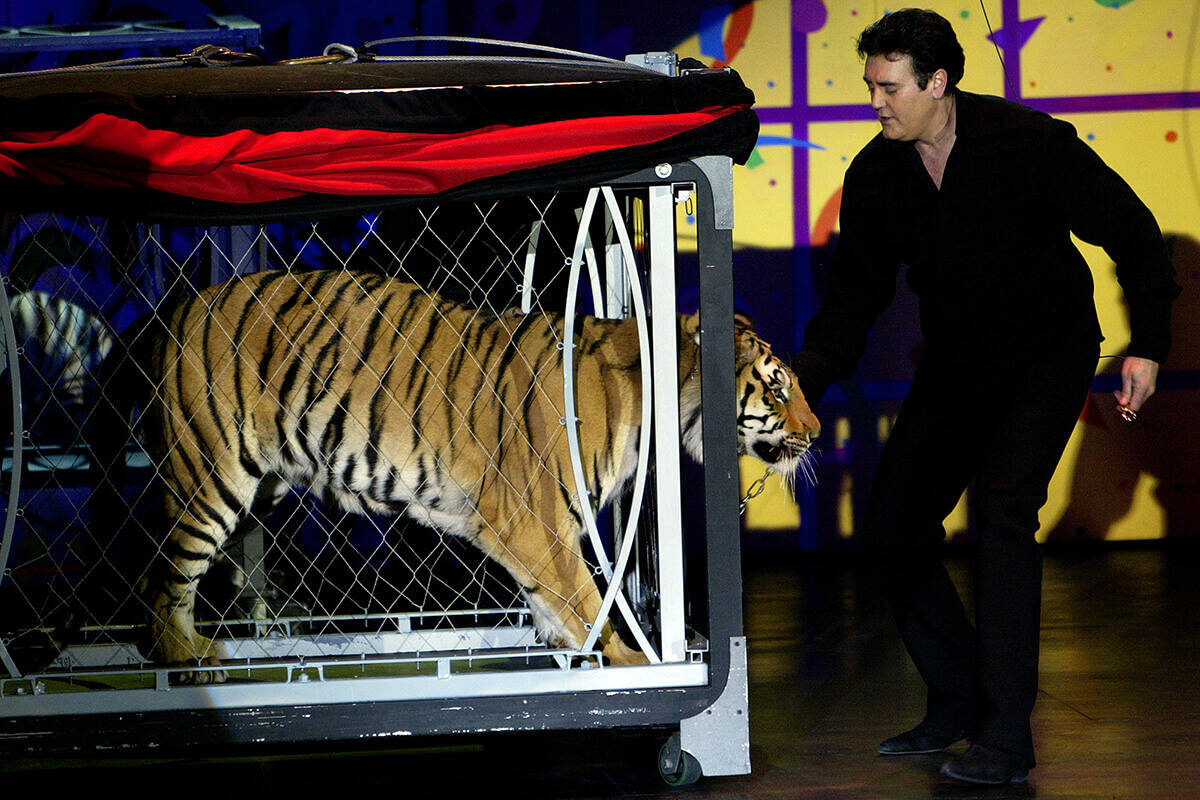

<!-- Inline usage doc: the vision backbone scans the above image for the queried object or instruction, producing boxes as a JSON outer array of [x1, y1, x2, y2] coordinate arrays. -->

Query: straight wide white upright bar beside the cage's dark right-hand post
[[649, 185, 688, 662]]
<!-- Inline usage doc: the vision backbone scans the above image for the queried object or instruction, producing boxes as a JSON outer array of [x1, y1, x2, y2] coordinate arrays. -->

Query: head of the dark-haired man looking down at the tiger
[[858, 8, 964, 142]]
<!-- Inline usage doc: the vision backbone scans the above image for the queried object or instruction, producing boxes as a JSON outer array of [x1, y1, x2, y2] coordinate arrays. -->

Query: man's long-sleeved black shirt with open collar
[[793, 91, 1180, 404]]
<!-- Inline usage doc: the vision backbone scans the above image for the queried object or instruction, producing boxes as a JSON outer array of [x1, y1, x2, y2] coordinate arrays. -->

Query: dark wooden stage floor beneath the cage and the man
[[0, 546, 1200, 800]]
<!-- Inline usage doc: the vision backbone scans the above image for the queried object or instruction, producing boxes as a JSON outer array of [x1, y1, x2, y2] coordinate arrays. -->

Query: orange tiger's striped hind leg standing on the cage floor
[[148, 470, 257, 684]]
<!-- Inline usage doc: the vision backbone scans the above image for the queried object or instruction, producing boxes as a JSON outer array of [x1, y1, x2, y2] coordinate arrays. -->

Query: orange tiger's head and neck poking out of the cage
[[680, 314, 821, 480]]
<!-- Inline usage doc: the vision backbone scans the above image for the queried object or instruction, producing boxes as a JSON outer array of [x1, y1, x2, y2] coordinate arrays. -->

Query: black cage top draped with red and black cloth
[[0, 59, 758, 222]]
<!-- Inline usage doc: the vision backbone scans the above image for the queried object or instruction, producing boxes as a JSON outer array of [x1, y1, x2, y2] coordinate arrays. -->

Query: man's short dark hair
[[858, 8, 966, 92]]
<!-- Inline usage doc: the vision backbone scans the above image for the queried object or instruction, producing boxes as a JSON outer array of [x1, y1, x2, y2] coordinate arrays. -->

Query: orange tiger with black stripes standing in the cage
[[114, 270, 820, 684]]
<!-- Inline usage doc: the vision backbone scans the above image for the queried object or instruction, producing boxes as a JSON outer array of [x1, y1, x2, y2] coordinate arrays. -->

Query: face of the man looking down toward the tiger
[[863, 55, 944, 142]]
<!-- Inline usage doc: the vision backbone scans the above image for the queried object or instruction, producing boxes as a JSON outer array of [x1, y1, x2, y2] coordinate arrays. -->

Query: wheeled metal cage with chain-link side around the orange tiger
[[0, 157, 749, 775]]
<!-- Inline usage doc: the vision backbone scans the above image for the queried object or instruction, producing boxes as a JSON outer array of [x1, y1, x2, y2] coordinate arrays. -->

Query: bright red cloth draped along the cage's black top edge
[[0, 107, 745, 204]]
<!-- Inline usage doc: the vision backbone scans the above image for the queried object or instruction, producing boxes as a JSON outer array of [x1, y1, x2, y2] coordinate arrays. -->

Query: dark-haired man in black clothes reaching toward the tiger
[[793, 8, 1178, 783]]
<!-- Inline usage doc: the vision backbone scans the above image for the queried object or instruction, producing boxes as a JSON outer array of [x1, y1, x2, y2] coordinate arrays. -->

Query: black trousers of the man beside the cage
[[865, 344, 1098, 766]]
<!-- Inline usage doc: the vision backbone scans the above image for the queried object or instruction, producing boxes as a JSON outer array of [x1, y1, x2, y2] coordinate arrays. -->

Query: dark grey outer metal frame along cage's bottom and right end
[[0, 156, 750, 775]]
